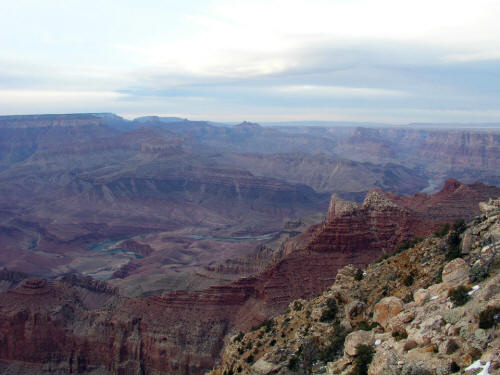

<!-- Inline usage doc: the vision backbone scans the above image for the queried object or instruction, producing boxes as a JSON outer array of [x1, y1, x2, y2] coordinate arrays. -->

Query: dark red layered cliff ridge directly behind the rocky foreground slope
[[0, 182, 500, 374]]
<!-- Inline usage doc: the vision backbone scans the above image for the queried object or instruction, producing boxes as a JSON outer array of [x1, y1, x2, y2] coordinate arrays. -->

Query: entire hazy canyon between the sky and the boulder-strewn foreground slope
[[0, 114, 500, 374]]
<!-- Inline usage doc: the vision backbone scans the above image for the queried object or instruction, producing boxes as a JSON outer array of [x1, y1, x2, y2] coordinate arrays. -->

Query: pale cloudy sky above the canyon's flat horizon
[[0, 0, 500, 123]]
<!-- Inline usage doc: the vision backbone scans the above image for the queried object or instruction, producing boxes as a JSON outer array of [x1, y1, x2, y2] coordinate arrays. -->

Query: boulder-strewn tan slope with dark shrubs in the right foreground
[[211, 199, 500, 375]]
